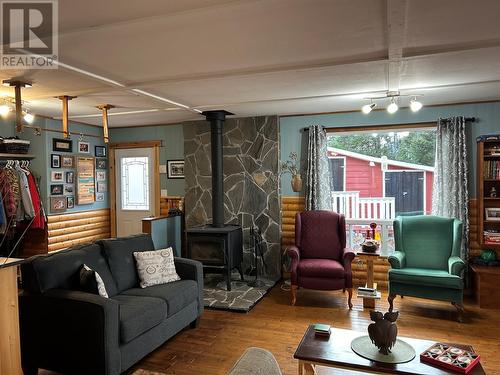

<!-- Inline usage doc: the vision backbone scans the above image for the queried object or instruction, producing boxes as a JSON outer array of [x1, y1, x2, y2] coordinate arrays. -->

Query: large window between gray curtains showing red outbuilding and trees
[[328, 128, 436, 220]]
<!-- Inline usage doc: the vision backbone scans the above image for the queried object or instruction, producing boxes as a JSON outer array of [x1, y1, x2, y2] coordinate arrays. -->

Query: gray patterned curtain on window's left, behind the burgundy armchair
[[306, 125, 332, 210]]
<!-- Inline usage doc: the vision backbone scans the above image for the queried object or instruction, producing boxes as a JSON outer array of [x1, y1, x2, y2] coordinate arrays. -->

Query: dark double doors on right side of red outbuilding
[[385, 171, 424, 215]]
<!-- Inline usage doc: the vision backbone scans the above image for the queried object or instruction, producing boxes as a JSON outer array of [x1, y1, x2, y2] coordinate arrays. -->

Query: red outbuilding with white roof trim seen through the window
[[328, 147, 434, 217]]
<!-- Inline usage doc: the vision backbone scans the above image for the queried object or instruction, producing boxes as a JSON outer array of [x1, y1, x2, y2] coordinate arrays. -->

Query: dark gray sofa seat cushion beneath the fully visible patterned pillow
[[122, 280, 198, 317]]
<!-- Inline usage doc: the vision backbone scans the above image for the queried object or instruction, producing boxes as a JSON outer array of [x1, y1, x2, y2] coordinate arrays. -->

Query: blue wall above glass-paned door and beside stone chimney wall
[[109, 124, 184, 195]]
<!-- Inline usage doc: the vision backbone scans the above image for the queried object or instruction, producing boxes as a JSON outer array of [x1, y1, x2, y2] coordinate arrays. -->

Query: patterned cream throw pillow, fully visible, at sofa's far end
[[134, 247, 181, 288]]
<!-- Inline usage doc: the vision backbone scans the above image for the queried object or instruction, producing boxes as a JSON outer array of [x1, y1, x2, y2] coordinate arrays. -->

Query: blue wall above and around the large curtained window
[[280, 103, 500, 197]]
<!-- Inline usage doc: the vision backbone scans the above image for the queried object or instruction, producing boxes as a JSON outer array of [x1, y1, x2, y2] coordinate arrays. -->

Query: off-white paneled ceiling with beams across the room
[[0, 0, 500, 127]]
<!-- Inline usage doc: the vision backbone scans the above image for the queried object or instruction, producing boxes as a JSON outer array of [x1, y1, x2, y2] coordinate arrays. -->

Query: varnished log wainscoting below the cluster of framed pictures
[[47, 209, 111, 252]]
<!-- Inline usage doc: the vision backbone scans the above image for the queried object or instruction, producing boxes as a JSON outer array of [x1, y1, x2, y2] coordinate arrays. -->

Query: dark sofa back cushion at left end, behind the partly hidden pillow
[[21, 244, 117, 297]]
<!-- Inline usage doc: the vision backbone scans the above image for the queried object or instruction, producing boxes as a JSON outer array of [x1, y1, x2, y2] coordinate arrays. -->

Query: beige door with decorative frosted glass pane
[[115, 148, 157, 237]]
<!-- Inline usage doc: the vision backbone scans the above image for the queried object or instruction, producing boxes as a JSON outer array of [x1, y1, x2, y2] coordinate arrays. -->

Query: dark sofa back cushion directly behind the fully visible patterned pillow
[[98, 234, 155, 293]]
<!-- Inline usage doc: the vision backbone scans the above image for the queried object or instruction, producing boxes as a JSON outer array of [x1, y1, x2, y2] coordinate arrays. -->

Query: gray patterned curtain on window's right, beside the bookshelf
[[432, 116, 469, 261]]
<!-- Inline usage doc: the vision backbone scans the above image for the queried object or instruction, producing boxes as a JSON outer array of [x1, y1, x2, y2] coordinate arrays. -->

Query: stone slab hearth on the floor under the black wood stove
[[203, 274, 277, 312]]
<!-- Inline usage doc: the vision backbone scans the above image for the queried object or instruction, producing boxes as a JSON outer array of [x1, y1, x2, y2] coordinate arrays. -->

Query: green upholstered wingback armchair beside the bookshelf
[[388, 215, 465, 321]]
